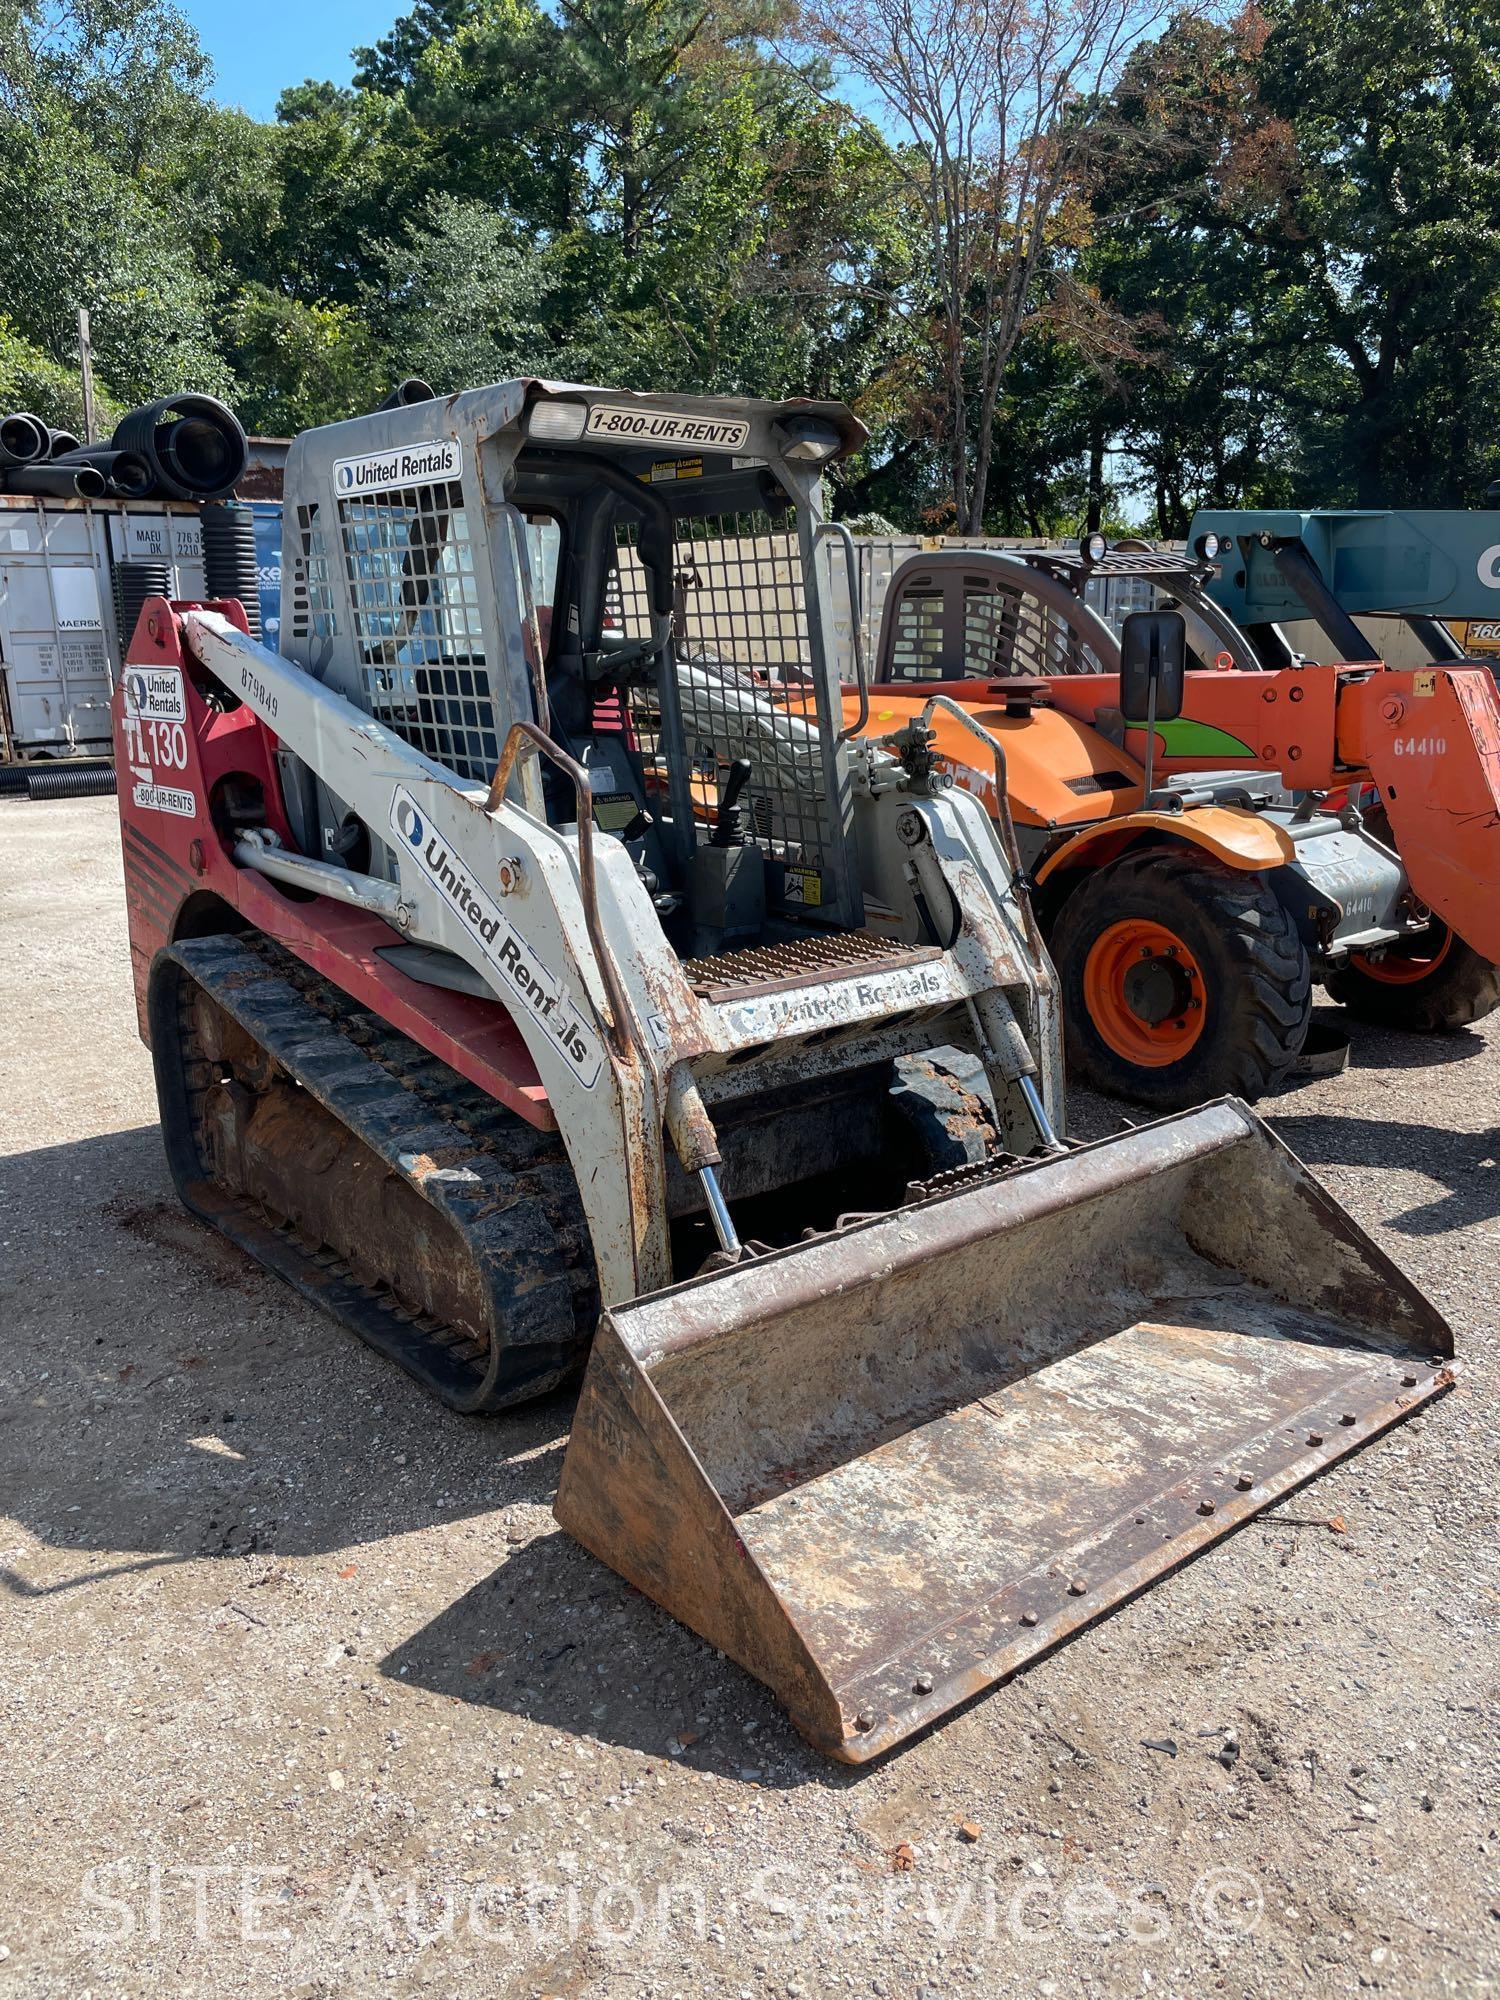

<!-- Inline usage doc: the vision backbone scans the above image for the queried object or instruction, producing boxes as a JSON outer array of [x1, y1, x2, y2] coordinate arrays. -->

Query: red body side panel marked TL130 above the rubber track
[[110, 598, 554, 1130]]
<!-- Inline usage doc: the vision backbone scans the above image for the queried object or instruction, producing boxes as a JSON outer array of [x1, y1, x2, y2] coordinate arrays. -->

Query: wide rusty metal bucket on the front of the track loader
[[556, 1098, 1452, 1762]]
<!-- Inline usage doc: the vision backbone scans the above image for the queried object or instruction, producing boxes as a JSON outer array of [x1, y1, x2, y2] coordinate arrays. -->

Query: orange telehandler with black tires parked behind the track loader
[[846, 546, 1500, 1110]]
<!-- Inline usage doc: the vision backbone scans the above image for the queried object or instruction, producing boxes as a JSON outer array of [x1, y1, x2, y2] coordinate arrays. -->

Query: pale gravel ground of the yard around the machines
[[0, 800, 1500, 2000]]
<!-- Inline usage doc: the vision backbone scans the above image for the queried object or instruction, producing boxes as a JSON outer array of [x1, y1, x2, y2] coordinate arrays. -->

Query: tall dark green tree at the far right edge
[[1234, 0, 1500, 506]]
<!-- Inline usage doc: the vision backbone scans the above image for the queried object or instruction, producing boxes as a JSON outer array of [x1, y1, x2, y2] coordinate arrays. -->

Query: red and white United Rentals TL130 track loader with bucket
[[114, 382, 1452, 1762]]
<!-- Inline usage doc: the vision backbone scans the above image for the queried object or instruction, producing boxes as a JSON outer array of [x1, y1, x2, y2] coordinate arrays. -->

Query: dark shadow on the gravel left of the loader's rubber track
[[0, 1126, 572, 1602]]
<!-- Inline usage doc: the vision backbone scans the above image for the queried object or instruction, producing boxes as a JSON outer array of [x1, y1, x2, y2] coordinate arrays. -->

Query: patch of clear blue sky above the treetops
[[180, 0, 410, 118]]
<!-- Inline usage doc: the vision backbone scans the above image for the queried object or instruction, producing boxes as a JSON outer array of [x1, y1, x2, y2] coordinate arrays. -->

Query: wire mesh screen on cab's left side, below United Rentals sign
[[338, 482, 500, 782]]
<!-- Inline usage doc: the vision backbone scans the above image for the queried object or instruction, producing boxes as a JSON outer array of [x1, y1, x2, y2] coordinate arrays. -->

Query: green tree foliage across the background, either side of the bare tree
[[0, 0, 1500, 532]]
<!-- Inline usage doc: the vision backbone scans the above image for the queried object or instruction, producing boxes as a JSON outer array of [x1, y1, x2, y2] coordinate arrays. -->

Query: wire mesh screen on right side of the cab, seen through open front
[[606, 514, 836, 908]]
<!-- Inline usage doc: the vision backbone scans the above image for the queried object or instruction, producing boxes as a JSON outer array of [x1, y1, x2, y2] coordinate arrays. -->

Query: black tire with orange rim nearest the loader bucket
[[1052, 848, 1312, 1112]]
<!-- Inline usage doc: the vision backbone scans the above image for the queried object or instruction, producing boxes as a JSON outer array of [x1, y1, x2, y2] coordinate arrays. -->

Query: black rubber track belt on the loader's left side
[[152, 934, 598, 1412]]
